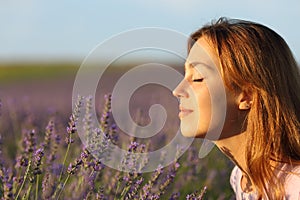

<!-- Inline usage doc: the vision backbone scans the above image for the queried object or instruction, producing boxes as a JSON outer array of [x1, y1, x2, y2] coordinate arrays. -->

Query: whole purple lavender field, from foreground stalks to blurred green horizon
[[0, 63, 234, 199]]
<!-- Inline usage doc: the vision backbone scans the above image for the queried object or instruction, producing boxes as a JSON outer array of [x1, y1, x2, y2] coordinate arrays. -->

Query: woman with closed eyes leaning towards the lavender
[[173, 18, 300, 200]]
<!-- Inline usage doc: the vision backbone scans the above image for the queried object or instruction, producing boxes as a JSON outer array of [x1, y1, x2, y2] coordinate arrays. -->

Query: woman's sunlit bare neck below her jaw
[[215, 132, 248, 174]]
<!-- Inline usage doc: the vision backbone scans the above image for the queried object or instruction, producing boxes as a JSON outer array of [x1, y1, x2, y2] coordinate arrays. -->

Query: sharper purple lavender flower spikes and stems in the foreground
[[0, 95, 234, 199]]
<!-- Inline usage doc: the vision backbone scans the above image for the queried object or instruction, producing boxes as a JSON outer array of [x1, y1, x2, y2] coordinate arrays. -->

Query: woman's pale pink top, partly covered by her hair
[[230, 165, 300, 200]]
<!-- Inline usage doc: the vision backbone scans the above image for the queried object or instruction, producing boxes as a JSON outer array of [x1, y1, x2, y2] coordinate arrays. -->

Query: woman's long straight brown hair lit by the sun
[[188, 18, 300, 199]]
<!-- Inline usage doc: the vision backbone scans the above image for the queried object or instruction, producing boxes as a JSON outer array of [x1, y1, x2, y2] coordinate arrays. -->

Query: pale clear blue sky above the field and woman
[[0, 0, 300, 62]]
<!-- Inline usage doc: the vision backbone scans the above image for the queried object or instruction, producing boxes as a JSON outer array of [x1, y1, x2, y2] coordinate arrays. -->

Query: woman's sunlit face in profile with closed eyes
[[173, 38, 243, 140]]
